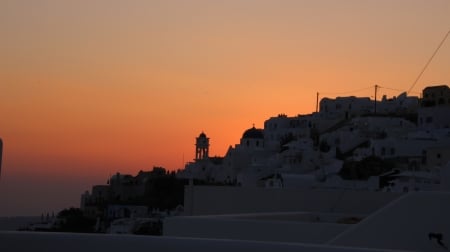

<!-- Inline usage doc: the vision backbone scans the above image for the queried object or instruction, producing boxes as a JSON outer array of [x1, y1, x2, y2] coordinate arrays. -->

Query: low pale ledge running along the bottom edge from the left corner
[[0, 232, 402, 252]]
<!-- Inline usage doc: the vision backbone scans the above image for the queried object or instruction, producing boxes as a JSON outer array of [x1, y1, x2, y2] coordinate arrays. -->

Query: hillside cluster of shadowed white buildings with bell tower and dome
[[178, 85, 450, 191]]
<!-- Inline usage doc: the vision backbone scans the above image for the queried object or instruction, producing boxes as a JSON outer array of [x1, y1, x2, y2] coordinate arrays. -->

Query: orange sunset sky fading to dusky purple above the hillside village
[[0, 0, 450, 216]]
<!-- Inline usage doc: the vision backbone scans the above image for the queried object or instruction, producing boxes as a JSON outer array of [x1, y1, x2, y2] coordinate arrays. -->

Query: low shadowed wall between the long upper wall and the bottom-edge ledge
[[163, 216, 351, 244]]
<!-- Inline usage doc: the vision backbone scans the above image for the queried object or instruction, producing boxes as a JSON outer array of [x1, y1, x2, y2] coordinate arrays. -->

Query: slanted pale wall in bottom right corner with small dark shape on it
[[329, 192, 450, 251]]
